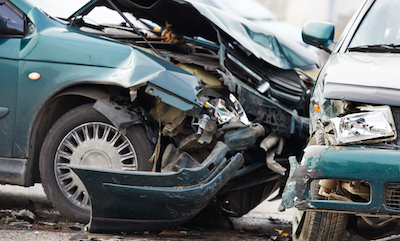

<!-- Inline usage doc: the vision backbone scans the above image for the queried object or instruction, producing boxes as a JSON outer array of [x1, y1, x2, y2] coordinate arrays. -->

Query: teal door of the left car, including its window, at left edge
[[0, 0, 25, 157]]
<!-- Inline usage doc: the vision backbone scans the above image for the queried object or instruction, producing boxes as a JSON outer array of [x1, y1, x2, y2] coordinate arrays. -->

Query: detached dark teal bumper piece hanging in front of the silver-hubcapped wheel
[[71, 142, 244, 232]]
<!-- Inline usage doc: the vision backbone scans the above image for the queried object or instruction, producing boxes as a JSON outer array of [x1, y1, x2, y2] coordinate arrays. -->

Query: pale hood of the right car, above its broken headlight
[[321, 52, 400, 106]]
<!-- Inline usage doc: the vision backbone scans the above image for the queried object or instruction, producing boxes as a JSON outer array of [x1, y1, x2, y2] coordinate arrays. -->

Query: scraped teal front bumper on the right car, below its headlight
[[280, 146, 400, 216]]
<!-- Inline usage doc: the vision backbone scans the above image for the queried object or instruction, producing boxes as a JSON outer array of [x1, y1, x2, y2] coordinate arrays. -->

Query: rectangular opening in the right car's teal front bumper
[[309, 179, 371, 203]]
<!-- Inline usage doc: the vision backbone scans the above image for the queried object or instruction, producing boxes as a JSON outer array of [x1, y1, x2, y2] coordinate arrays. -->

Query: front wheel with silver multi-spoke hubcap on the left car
[[39, 104, 153, 223]]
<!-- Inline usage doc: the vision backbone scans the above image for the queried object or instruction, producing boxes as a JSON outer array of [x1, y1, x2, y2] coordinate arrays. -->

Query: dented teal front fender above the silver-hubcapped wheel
[[13, 5, 200, 158]]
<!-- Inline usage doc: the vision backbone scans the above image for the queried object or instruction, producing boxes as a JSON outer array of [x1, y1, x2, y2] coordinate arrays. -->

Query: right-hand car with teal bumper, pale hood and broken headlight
[[280, 0, 400, 240]]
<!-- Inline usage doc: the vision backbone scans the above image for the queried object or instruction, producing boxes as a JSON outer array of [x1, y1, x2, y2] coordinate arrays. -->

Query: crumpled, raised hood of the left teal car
[[103, 0, 319, 69]]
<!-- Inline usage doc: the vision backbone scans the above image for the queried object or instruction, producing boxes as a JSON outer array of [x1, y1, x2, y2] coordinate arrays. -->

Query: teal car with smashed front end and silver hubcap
[[0, 0, 318, 231]]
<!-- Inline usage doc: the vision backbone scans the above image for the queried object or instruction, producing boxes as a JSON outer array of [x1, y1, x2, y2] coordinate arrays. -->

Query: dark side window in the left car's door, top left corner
[[0, 1, 25, 38]]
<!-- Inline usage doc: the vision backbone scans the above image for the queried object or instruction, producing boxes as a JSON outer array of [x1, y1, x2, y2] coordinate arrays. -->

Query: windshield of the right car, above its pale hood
[[349, 0, 400, 50]]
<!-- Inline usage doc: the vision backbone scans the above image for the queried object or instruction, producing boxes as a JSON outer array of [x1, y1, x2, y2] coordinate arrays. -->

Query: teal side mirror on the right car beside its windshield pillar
[[301, 21, 335, 53]]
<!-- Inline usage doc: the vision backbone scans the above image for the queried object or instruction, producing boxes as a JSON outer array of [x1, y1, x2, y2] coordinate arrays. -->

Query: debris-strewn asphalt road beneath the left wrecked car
[[0, 184, 292, 241]]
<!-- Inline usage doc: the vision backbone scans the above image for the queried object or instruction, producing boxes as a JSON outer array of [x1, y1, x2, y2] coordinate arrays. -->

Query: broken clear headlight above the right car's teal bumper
[[331, 106, 397, 145]]
